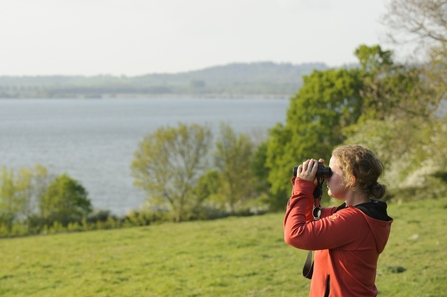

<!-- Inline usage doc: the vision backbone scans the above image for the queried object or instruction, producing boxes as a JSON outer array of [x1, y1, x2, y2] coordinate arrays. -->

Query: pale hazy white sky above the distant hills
[[0, 0, 389, 76]]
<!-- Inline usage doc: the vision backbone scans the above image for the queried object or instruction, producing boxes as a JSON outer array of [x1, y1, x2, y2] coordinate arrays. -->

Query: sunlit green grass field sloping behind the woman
[[0, 198, 447, 297]]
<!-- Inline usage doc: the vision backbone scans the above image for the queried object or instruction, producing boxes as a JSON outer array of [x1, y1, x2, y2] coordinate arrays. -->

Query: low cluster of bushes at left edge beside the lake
[[0, 165, 92, 236]]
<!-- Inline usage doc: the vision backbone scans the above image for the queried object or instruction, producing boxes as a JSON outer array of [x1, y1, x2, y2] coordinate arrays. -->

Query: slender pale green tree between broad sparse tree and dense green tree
[[214, 123, 254, 213]]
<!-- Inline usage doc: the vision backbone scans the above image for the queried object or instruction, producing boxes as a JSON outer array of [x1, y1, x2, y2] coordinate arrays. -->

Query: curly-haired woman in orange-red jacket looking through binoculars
[[284, 145, 393, 297]]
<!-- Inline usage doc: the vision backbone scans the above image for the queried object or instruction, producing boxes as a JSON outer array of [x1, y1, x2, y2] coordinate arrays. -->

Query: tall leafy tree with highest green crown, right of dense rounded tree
[[344, 46, 436, 165]]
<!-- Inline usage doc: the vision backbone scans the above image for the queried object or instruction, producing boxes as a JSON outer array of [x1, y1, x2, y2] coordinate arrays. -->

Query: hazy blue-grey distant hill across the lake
[[0, 62, 328, 98]]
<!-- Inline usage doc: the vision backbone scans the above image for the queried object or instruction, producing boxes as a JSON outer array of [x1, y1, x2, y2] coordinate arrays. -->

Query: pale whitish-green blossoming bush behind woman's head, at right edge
[[346, 117, 447, 200]]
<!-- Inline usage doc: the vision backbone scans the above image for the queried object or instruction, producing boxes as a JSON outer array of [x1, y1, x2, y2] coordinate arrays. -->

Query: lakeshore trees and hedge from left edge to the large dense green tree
[[0, 123, 265, 237]]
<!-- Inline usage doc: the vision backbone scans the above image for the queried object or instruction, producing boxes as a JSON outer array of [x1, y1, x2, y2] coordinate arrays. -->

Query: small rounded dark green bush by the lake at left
[[39, 173, 92, 226]]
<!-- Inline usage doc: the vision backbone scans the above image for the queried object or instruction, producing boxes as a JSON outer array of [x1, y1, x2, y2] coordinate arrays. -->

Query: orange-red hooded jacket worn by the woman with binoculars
[[284, 178, 393, 297]]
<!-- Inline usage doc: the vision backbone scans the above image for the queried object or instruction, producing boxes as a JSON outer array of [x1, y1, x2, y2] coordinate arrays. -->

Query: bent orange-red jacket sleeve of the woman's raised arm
[[284, 179, 366, 250]]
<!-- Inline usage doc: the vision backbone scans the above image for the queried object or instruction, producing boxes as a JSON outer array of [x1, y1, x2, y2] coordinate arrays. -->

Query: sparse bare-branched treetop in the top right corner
[[382, 0, 447, 110]]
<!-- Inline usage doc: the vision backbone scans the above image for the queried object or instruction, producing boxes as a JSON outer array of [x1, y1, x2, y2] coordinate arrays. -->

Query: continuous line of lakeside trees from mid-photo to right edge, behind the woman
[[132, 45, 447, 221]]
